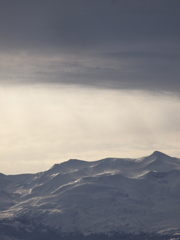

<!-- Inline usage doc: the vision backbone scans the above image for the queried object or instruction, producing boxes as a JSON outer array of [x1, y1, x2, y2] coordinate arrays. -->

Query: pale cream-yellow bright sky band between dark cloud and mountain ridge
[[0, 85, 180, 174]]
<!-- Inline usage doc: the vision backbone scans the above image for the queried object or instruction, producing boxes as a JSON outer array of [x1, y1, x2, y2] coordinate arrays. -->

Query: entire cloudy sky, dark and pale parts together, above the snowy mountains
[[0, 0, 180, 174]]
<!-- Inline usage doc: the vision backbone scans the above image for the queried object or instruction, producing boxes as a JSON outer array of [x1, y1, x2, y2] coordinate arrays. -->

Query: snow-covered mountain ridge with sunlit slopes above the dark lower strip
[[0, 151, 180, 239]]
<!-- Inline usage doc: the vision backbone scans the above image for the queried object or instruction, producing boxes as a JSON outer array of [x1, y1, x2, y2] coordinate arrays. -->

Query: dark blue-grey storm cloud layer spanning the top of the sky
[[0, 0, 180, 91]]
